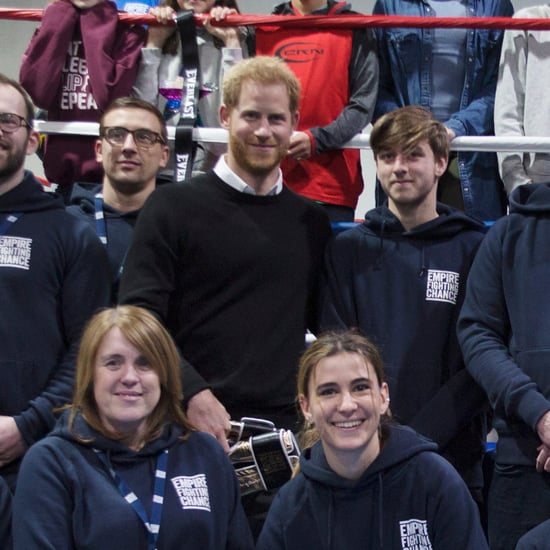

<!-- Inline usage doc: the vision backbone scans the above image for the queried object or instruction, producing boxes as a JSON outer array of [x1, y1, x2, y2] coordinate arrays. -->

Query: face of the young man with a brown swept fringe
[[376, 140, 447, 210]]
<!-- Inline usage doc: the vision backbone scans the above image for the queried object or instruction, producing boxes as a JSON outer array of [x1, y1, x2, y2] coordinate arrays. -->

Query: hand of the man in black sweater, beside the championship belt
[[187, 390, 231, 453]]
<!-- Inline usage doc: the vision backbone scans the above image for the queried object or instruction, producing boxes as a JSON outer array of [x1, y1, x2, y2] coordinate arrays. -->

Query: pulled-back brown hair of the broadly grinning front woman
[[297, 330, 391, 447]]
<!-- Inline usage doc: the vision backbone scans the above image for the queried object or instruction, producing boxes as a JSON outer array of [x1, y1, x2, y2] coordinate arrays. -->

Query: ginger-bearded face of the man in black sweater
[[220, 79, 298, 191]]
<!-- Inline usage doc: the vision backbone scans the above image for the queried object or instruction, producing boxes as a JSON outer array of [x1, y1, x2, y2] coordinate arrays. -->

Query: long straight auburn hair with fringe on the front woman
[[69, 305, 193, 443]]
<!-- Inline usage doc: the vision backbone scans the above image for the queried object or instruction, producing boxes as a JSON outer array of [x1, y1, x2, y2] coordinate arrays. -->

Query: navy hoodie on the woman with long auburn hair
[[13, 411, 253, 550]]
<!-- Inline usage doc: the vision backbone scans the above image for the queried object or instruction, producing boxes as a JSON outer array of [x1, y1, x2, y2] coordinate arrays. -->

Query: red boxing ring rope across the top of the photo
[[4, 8, 550, 31]]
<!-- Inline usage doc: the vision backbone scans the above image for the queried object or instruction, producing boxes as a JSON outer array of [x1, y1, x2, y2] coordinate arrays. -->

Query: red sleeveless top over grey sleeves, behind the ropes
[[256, 4, 372, 208]]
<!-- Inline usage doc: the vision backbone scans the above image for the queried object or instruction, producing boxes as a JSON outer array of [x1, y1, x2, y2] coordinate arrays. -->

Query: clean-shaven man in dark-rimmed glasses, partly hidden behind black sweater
[[67, 97, 170, 303]]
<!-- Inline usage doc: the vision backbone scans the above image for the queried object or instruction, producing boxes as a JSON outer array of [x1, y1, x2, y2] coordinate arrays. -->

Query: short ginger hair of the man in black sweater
[[223, 55, 300, 115]]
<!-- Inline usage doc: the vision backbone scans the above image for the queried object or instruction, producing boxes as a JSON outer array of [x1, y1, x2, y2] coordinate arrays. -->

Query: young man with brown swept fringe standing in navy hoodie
[[321, 106, 486, 503]]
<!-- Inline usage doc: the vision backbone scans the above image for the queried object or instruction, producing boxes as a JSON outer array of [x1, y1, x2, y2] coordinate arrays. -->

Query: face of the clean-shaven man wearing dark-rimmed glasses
[[96, 108, 170, 195]]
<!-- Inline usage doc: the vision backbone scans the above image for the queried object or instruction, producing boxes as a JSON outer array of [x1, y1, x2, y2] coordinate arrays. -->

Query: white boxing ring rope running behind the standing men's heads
[[34, 120, 550, 153]]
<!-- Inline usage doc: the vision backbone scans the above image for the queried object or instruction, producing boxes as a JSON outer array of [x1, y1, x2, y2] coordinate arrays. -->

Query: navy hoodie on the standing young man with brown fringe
[[321, 204, 486, 487]]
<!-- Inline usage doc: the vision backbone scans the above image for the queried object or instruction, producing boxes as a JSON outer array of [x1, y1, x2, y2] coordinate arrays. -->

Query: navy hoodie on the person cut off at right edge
[[458, 183, 550, 467]]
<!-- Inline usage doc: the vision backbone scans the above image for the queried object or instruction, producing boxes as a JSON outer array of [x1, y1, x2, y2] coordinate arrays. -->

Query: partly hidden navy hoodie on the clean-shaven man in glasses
[[67, 183, 140, 302]]
